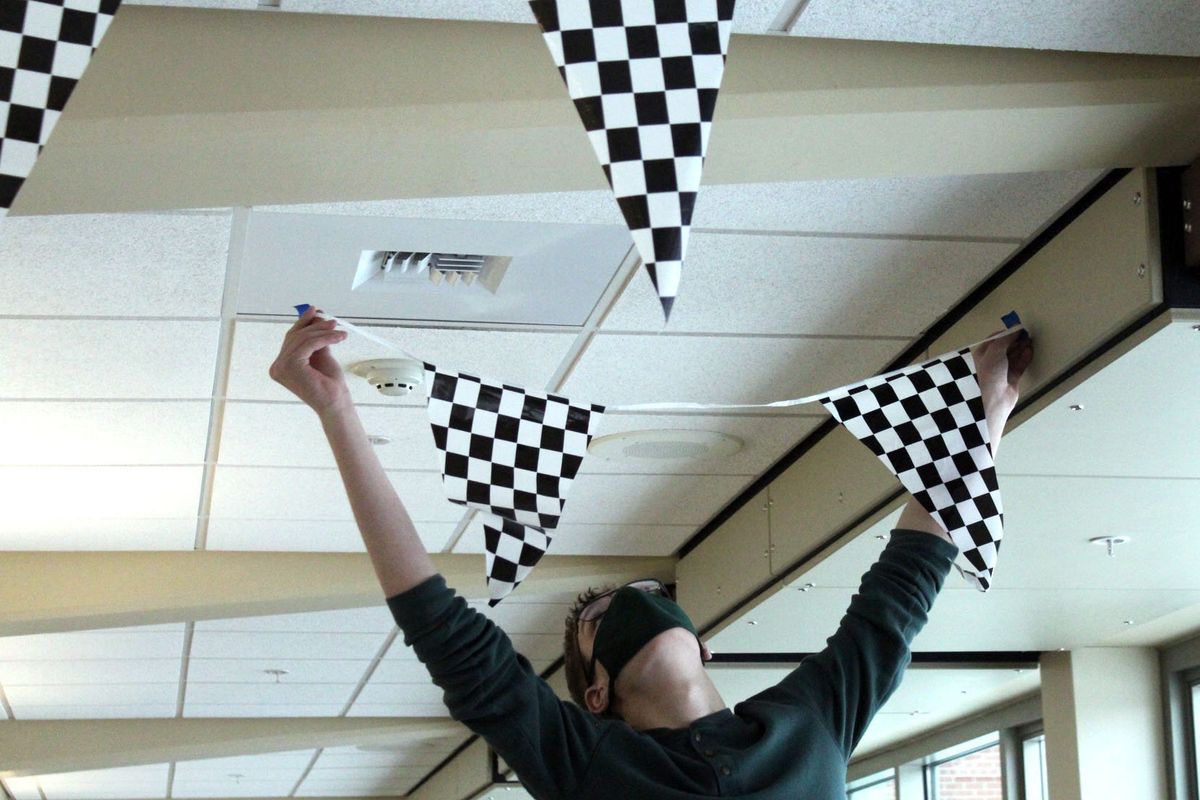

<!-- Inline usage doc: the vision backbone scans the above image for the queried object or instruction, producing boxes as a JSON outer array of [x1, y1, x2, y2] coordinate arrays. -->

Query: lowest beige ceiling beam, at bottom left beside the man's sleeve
[[0, 717, 467, 777]]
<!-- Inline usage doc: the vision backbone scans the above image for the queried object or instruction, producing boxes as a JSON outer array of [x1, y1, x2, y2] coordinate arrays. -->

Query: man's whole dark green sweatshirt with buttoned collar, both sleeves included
[[388, 530, 958, 800]]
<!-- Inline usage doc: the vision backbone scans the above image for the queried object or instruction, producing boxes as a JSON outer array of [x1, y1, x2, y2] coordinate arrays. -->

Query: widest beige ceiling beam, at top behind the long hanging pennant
[[13, 6, 1200, 213]]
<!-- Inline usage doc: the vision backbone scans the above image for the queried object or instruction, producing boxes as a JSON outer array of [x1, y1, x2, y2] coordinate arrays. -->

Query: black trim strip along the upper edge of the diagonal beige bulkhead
[[676, 168, 1132, 558]]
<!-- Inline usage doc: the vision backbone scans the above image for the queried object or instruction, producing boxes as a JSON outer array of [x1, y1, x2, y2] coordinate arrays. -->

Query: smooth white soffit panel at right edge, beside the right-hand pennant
[[997, 321, 1200, 482]]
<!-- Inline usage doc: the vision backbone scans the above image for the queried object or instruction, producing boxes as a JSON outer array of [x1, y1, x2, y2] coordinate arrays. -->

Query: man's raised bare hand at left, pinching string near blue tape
[[270, 308, 350, 417]]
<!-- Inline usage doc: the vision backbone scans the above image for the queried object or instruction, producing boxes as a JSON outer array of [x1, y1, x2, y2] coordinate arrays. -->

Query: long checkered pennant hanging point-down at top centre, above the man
[[529, 0, 734, 318]]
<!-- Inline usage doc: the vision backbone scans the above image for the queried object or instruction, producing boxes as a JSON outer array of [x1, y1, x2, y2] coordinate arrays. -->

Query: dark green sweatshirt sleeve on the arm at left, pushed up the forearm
[[388, 575, 601, 800]]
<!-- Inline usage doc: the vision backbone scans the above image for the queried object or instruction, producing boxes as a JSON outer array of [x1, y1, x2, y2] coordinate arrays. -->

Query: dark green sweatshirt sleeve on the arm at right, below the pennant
[[762, 530, 958, 759]]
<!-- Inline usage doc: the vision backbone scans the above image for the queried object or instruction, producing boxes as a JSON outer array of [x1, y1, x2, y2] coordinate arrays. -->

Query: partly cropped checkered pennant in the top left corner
[[0, 0, 121, 217]]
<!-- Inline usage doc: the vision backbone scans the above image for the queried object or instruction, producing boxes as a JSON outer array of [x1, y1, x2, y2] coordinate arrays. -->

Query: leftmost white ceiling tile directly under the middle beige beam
[[0, 625, 184, 668]]
